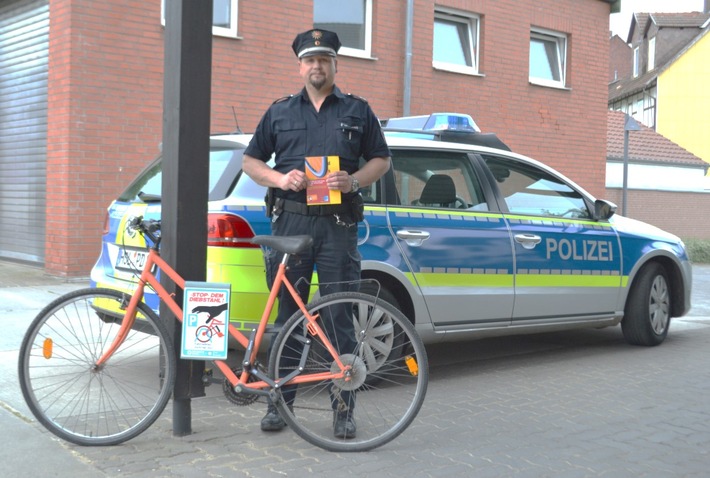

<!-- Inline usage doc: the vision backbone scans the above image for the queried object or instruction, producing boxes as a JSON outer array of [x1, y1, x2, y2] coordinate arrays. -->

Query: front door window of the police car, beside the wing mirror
[[483, 155, 592, 219]]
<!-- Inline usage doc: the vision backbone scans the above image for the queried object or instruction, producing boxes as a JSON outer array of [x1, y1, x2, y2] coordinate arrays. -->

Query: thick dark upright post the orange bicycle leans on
[[160, 0, 212, 436]]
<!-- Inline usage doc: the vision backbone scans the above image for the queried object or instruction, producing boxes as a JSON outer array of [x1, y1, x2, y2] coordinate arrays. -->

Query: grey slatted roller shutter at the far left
[[0, 0, 49, 263]]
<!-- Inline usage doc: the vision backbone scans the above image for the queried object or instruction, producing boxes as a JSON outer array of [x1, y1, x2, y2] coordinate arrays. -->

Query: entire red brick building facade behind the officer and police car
[[45, 0, 609, 276]]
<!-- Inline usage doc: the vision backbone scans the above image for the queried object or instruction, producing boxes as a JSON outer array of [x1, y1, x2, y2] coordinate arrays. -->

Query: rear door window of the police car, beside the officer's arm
[[370, 150, 486, 210]]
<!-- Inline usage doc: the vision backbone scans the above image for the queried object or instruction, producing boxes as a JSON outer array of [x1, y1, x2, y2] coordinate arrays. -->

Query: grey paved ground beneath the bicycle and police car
[[0, 261, 710, 478]]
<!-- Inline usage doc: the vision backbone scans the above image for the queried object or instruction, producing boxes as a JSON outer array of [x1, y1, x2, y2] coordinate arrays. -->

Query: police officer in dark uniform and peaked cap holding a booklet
[[243, 29, 390, 438]]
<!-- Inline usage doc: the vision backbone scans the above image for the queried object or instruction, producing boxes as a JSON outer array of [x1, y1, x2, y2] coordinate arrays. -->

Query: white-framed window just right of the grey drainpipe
[[433, 10, 480, 74]]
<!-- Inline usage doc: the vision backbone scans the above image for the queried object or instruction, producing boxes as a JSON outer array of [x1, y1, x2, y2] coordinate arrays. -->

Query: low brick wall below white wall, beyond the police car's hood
[[605, 188, 710, 240]]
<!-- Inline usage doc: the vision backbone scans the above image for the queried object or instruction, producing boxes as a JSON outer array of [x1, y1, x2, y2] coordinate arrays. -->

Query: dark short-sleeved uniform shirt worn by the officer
[[245, 86, 390, 202]]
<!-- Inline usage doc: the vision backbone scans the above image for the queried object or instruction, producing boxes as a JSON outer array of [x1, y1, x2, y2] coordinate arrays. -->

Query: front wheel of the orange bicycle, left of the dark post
[[18, 289, 176, 446]]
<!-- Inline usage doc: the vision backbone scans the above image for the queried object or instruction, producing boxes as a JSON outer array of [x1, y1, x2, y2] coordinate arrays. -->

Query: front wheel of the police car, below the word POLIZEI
[[621, 263, 671, 346]]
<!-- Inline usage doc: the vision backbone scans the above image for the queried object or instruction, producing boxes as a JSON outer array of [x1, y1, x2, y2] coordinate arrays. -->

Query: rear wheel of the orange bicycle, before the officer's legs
[[269, 292, 429, 452]]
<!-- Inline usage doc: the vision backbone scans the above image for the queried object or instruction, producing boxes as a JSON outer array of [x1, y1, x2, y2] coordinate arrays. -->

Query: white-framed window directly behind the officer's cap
[[313, 0, 372, 58]]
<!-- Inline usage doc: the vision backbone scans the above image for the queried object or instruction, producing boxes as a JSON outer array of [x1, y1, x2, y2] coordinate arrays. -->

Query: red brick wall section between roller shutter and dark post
[[45, 0, 163, 276]]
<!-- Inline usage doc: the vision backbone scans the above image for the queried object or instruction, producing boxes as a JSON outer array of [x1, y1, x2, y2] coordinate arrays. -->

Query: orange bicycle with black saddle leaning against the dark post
[[18, 218, 429, 451]]
